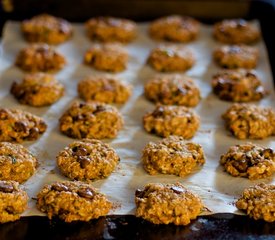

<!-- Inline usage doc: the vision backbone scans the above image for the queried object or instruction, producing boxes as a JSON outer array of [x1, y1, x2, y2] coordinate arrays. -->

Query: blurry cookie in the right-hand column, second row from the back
[[213, 45, 259, 69]]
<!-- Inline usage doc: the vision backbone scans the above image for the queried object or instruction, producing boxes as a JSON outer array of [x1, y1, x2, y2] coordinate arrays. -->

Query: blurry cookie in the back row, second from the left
[[85, 17, 137, 43]]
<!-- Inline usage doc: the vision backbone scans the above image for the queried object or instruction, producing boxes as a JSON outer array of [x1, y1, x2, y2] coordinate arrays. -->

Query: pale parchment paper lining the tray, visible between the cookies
[[0, 21, 275, 216]]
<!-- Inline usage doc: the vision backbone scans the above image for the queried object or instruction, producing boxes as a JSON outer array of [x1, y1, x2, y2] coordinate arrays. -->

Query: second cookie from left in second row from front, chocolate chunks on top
[[56, 139, 119, 181]]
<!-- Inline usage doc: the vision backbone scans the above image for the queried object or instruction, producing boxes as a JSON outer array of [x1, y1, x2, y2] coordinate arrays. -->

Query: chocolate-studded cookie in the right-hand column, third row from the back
[[212, 69, 268, 102]]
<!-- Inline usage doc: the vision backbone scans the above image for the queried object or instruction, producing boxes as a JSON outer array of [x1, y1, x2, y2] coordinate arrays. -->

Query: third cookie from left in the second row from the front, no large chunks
[[142, 136, 205, 177]]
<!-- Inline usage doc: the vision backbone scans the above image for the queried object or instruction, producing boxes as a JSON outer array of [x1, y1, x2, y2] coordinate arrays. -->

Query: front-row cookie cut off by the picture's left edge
[[0, 180, 28, 223]]
